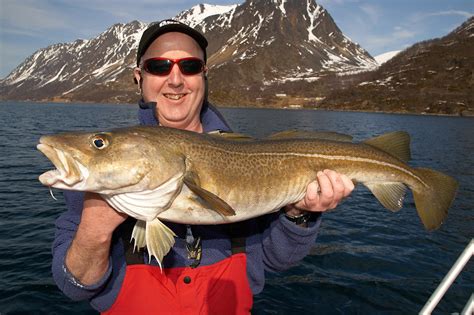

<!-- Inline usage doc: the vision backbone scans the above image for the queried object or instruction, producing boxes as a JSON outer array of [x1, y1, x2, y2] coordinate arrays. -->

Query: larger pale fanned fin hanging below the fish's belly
[[145, 219, 176, 268]]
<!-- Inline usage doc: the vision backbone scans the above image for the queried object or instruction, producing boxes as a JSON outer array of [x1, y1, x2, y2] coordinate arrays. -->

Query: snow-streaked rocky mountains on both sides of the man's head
[[0, 0, 378, 104]]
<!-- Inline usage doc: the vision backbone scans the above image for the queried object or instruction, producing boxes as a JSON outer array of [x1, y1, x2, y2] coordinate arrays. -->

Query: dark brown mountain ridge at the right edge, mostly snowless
[[319, 17, 474, 116]]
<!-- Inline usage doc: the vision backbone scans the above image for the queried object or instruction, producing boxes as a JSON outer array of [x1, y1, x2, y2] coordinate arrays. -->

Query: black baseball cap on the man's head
[[137, 20, 207, 67]]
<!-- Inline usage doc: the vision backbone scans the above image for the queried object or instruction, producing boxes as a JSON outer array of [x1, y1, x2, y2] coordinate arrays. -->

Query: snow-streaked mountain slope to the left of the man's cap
[[0, 21, 147, 102]]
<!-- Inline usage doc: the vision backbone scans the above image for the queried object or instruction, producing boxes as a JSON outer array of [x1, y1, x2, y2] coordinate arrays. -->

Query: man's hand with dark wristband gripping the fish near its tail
[[284, 170, 354, 216]]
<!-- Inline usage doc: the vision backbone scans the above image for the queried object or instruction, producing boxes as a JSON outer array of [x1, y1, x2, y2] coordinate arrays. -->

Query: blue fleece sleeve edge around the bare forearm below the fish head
[[51, 191, 112, 301]]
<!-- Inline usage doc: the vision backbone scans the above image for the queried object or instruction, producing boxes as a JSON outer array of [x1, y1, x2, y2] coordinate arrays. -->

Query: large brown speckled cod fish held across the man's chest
[[37, 126, 458, 262]]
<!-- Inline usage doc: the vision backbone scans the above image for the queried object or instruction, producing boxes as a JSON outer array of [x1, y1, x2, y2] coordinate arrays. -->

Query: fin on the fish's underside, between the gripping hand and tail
[[364, 182, 406, 211]]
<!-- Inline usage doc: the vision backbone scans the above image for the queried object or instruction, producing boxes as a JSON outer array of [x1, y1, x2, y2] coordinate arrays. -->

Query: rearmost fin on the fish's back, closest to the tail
[[364, 131, 411, 162]]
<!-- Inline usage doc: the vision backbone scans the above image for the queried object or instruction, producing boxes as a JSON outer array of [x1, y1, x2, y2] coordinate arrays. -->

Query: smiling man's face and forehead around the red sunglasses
[[135, 32, 205, 131]]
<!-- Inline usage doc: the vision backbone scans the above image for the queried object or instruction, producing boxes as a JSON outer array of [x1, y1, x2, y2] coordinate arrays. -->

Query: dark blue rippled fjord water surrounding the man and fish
[[0, 102, 474, 315]]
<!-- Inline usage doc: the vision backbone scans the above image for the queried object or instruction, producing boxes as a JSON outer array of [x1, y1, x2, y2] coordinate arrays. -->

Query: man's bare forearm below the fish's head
[[65, 193, 127, 285]]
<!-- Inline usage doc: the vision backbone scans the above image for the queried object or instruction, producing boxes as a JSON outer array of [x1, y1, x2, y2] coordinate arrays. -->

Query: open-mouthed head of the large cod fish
[[37, 129, 184, 194]]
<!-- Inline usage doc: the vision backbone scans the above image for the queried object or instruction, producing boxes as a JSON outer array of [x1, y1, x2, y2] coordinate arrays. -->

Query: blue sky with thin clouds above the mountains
[[0, 0, 474, 78]]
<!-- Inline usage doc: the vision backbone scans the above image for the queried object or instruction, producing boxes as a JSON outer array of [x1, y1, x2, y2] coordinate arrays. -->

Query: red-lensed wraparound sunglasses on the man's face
[[143, 57, 205, 76]]
